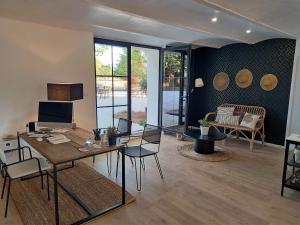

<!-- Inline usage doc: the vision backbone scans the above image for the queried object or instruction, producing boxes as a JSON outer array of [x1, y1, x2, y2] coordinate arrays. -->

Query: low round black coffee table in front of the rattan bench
[[184, 127, 227, 154]]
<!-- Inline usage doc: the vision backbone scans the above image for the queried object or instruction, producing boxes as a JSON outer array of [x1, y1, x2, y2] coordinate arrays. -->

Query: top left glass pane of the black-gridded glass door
[[95, 44, 112, 76]]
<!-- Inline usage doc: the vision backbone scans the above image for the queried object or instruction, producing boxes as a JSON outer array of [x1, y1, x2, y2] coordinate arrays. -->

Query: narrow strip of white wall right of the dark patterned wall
[[286, 39, 300, 136]]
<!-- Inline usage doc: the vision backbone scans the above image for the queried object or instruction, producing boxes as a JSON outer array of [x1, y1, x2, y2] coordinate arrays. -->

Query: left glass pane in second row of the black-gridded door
[[96, 76, 112, 106]]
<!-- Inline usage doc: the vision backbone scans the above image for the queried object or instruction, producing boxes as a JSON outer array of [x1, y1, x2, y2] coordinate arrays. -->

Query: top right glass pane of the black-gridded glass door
[[113, 46, 128, 76]]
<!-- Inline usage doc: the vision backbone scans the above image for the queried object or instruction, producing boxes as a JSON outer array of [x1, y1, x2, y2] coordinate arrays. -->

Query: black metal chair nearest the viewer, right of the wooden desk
[[117, 124, 164, 191]]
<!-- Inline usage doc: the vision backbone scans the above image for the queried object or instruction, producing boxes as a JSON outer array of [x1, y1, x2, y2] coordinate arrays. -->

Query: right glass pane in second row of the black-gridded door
[[113, 77, 127, 105]]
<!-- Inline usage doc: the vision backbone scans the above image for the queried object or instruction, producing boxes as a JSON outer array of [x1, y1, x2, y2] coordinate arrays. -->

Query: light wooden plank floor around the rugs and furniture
[[0, 136, 300, 225]]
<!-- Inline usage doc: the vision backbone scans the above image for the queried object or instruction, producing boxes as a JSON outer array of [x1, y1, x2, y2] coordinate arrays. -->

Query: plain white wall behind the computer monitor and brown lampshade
[[0, 18, 96, 137]]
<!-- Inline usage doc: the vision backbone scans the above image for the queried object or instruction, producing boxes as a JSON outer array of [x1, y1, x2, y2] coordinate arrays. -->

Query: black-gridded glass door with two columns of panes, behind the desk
[[95, 43, 129, 128]]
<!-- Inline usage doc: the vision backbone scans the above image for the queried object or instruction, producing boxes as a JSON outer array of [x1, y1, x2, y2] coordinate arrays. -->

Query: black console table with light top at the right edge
[[281, 134, 300, 196]]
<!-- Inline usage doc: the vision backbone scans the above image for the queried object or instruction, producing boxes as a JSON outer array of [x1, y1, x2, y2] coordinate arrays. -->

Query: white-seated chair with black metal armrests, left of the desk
[[0, 148, 49, 218]]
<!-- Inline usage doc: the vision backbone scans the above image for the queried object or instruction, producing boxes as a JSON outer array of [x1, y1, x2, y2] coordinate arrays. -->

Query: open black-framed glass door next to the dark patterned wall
[[162, 48, 189, 131]]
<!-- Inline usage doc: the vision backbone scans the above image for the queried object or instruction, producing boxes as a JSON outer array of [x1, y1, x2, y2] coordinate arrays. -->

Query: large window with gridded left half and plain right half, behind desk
[[95, 41, 160, 132]]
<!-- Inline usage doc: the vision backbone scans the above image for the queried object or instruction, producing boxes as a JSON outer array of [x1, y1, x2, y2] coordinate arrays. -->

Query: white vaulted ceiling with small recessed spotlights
[[0, 0, 300, 48]]
